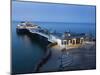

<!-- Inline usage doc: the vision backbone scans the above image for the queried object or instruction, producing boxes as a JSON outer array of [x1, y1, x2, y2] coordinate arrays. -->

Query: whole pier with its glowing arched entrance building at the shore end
[[17, 22, 85, 48]]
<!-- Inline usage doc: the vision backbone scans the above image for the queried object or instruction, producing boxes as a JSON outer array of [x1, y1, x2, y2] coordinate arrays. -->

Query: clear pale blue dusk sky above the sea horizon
[[12, 1, 96, 23]]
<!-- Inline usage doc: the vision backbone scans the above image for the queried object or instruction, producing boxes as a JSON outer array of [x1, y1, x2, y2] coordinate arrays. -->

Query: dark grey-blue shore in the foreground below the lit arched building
[[39, 43, 96, 72]]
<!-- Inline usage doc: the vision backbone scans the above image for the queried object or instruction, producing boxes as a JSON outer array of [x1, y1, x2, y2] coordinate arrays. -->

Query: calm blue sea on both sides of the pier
[[12, 21, 95, 73]]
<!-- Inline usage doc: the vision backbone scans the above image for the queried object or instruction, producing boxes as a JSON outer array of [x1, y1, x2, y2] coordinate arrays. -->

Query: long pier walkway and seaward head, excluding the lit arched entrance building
[[17, 23, 59, 43]]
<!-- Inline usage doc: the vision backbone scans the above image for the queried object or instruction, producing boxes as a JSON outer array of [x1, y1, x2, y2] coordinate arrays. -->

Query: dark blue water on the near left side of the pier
[[12, 22, 44, 73]]
